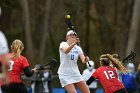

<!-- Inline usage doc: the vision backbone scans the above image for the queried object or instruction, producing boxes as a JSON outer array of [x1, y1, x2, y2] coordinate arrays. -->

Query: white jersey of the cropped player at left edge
[[0, 31, 9, 55]]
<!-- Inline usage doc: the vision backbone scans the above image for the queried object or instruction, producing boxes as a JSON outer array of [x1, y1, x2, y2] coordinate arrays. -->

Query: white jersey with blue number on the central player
[[58, 42, 83, 76]]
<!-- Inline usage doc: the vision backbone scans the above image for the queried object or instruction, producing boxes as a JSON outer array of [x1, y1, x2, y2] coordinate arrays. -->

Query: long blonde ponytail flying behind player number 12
[[106, 54, 127, 73]]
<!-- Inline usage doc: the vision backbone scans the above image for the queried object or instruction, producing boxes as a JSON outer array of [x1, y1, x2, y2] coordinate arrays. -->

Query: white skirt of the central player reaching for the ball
[[59, 74, 84, 87]]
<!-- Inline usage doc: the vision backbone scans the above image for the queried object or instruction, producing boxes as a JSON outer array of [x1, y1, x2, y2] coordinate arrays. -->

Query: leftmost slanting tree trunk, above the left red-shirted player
[[20, 0, 34, 60]]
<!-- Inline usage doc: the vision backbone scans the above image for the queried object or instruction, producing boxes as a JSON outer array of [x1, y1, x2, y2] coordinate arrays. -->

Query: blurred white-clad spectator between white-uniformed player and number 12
[[82, 60, 97, 93]]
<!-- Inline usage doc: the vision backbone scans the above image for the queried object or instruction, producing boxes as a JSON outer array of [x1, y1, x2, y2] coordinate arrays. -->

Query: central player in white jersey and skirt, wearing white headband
[[58, 30, 90, 93]]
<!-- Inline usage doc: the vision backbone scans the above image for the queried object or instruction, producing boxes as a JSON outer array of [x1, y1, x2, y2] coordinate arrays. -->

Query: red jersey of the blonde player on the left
[[8, 55, 29, 83]]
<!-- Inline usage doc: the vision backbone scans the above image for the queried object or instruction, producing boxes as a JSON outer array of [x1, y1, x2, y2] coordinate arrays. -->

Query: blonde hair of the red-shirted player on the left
[[11, 39, 24, 57]]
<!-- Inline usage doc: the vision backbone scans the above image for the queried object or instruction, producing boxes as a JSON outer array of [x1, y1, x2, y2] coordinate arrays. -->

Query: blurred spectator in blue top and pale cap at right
[[121, 63, 136, 93]]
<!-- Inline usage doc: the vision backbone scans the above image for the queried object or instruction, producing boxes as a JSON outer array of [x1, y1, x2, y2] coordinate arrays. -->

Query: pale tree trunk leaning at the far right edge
[[126, 0, 140, 55]]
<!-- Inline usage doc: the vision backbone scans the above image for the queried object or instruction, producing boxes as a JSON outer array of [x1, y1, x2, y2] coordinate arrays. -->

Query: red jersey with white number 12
[[92, 66, 124, 93]]
